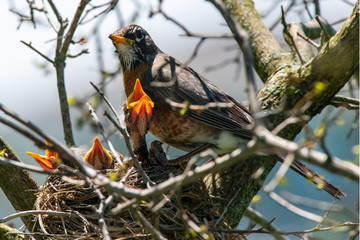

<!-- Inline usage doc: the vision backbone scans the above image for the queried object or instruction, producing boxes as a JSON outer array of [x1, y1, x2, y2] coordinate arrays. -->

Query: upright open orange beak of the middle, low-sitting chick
[[84, 137, 113, 170]]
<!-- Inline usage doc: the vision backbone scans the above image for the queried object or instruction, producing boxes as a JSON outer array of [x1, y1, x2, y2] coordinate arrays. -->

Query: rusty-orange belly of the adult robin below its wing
[[150, 109, 216, 151]]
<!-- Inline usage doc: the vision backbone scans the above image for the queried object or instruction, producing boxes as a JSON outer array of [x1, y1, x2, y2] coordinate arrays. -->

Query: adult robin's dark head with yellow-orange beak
[[109, 24, 159, 70]]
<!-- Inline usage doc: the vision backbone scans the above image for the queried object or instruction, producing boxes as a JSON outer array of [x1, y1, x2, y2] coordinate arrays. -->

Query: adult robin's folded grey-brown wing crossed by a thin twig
[[144, 54, 253, 139]]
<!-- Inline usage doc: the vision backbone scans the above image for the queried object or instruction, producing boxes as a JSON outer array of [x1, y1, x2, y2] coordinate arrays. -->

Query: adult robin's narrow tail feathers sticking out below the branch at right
[[290, 161, 346, 198]]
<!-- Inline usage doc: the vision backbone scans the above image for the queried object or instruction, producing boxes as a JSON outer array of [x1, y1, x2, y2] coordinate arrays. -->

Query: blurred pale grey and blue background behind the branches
[[0, 0, 359, 239]]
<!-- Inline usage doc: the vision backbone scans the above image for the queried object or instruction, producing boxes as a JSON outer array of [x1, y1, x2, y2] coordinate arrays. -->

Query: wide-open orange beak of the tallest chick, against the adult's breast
[[126, 79, 154, 116]]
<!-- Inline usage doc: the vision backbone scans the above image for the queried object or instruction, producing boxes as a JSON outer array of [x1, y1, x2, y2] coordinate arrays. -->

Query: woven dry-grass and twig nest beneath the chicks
[[35, 162, 235, 239]]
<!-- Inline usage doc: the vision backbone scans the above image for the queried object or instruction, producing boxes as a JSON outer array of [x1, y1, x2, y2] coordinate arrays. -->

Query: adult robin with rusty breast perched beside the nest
[[109, 24, 345, 196]]
